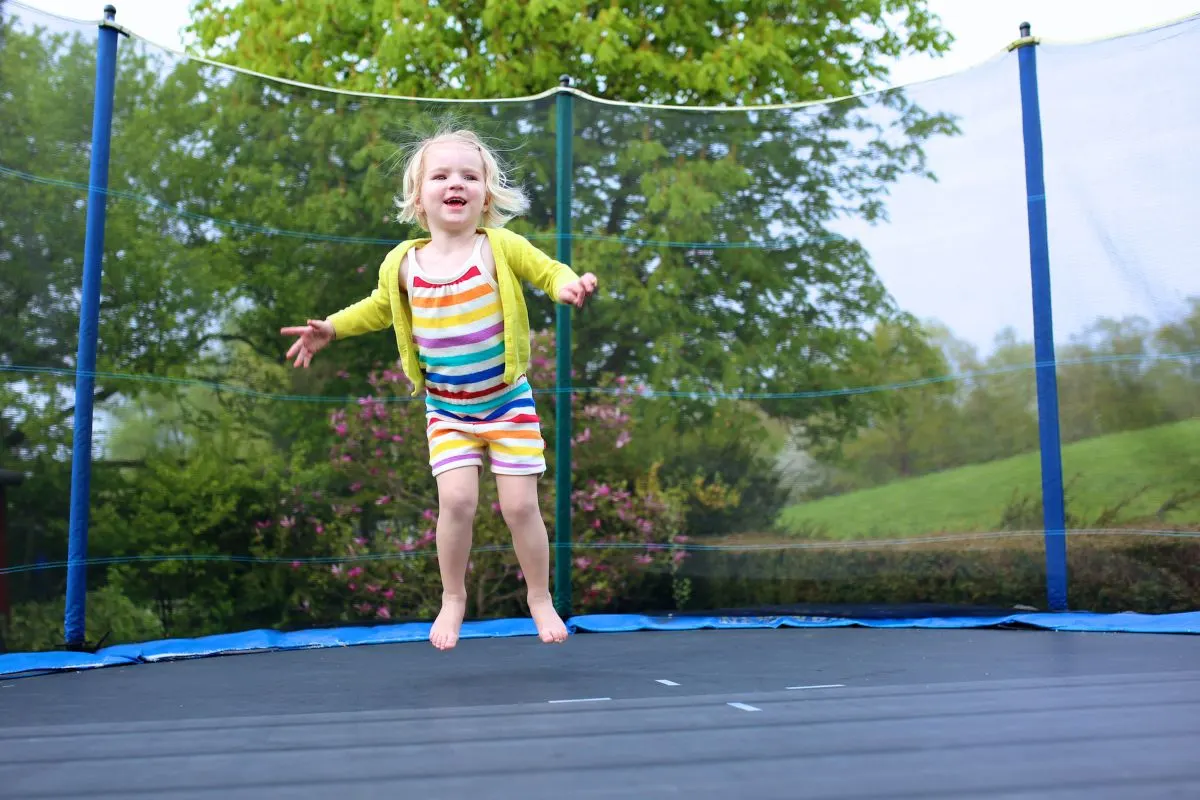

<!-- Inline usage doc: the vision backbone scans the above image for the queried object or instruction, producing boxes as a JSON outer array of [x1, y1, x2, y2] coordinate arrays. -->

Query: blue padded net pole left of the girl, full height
[[64, 6, 119, 650]]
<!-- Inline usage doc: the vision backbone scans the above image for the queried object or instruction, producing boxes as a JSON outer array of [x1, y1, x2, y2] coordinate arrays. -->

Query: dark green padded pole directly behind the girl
[[554, 76, 575, 618]]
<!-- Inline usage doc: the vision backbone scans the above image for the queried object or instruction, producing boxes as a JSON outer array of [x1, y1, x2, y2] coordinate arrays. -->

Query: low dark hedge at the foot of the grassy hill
[[618, 535, 1200, 614]]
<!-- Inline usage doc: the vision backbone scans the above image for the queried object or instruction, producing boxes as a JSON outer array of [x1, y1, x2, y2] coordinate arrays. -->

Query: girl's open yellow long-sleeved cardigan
[[328, 228, 578, 395]]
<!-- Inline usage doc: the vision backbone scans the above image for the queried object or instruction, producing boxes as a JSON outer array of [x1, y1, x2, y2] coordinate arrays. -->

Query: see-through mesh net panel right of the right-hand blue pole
[[1038, 18, 1200, 610]]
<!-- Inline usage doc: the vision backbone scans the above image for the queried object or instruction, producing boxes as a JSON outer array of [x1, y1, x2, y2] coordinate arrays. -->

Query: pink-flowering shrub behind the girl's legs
[[258, 332, 695, 621]]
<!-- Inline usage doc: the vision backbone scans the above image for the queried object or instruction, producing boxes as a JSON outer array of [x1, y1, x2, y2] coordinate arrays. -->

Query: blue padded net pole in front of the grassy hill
[[1013, 23, 1067, 610]]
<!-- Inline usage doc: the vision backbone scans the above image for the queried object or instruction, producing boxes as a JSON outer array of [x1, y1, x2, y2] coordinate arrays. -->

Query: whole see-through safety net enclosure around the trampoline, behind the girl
[[0, 2, 1200, 651]]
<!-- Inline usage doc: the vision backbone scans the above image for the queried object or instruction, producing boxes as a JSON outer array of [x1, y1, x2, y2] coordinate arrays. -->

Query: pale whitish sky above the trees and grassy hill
[[16, 0, 1200, 351]]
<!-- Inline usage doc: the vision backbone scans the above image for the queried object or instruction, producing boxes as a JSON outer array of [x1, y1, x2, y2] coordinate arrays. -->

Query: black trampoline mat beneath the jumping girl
[[0, 614, 1200, 799]]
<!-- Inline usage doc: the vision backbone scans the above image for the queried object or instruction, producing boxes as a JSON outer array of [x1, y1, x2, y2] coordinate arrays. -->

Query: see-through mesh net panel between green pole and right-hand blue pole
[[575, 54, 1045, 613]]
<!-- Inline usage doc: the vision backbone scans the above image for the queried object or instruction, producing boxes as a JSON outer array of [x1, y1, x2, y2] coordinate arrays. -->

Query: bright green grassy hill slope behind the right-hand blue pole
[[780, 420, 1200, 539]]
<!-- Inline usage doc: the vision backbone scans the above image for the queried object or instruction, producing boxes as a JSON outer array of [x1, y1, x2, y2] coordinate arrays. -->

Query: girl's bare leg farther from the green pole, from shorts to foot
[[430, 465, 479, 650]]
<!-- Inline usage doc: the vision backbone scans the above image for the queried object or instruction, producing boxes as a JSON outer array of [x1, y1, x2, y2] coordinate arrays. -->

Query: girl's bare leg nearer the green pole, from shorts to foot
[[496, 475, 566, 643]]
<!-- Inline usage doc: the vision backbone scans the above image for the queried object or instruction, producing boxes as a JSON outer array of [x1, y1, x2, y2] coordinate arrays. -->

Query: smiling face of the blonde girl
[[419, 140, 487, 233]]
